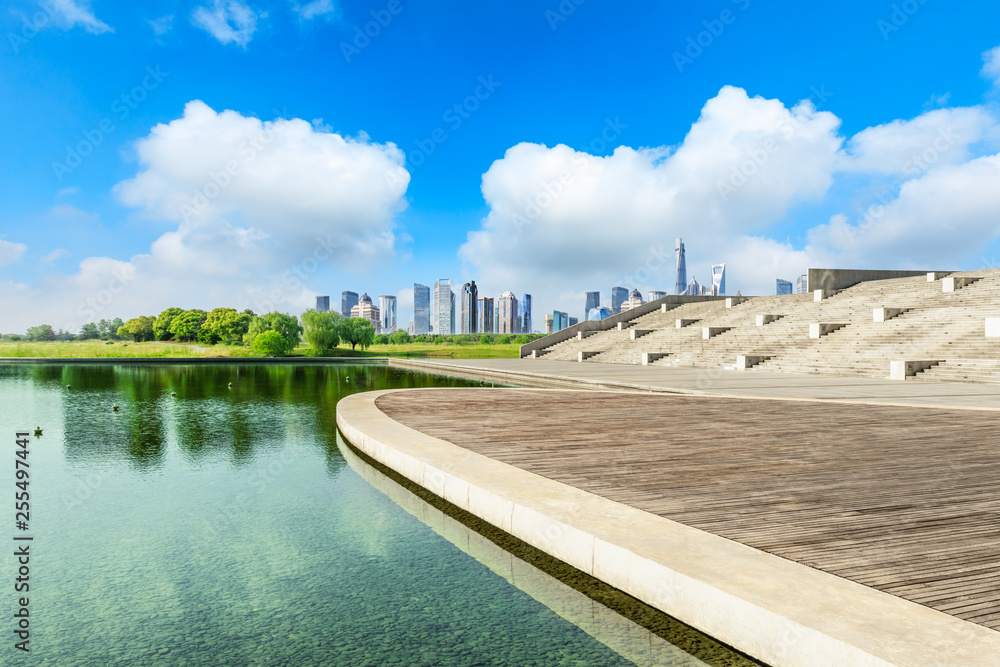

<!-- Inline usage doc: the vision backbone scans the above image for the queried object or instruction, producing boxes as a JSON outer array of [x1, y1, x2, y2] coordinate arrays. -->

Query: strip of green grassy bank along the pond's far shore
[[0, 340, 520, 359]]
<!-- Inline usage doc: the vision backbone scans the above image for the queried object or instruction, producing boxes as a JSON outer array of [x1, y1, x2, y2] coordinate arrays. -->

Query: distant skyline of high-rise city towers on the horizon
[[316, 239, 808, 335]]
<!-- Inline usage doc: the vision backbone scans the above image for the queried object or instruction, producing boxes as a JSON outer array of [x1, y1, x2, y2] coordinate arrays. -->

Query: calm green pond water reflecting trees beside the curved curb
[[0, 365, 752, 666]]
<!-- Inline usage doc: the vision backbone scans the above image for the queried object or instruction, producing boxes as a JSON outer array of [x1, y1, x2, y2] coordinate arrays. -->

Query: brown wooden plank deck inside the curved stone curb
[[377, 389, 1000, 630]]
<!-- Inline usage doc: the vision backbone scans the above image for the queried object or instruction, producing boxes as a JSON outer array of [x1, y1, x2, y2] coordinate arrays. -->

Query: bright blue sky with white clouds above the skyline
[[0, 0, 1000, 331]]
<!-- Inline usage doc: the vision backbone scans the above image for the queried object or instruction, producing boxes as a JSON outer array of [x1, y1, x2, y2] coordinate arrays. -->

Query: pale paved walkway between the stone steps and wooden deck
[[389, 359, 1000, 410]]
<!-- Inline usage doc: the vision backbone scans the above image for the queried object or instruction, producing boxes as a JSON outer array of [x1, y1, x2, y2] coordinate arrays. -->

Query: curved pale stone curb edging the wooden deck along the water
[[337, 389, 1000, 667]]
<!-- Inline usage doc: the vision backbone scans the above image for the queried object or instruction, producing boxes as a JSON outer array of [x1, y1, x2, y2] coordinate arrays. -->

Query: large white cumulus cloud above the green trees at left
[[0, 101, 409, 330]]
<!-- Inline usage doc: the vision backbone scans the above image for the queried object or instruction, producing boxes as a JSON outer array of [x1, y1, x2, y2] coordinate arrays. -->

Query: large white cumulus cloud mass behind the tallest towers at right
[[459, 87, 1000, 321]]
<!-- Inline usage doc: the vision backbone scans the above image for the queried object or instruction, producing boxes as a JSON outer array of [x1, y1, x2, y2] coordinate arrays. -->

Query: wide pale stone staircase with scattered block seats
[[540, 269, 1000, 383]]
